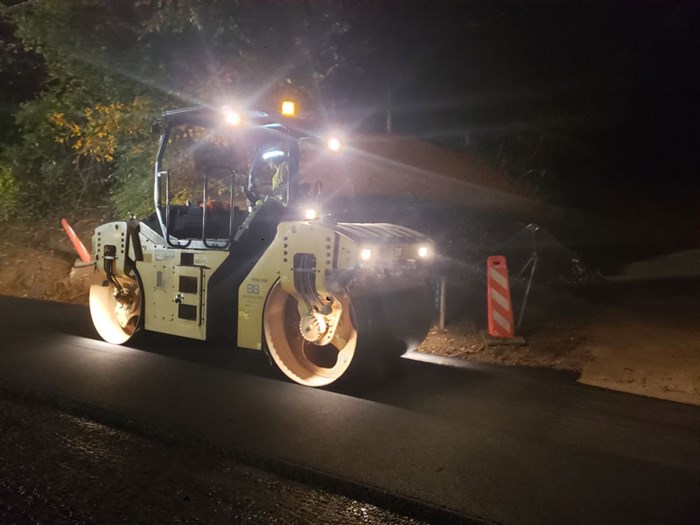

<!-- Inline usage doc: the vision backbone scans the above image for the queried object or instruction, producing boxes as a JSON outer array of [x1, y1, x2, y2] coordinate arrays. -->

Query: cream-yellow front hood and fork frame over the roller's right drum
[[238, 222, 433, 349]]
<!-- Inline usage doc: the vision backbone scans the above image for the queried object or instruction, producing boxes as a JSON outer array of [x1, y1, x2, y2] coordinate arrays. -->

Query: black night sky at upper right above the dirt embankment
[[332, 0, 700, 190]]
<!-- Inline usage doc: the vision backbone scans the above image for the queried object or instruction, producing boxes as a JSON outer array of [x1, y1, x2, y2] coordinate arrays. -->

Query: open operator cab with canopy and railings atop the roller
[[153, 106, 306, 249]]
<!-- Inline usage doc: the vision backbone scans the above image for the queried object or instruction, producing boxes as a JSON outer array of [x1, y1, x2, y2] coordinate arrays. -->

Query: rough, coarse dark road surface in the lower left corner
[[0, 390, 422, 525]]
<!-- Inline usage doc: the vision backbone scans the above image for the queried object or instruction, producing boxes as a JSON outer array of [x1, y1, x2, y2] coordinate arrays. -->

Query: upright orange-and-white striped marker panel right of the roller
[[486, 255, 515, 337]]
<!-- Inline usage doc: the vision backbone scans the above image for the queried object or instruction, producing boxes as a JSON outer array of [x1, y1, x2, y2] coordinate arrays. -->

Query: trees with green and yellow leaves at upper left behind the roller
[[0, 0, 356, 216]]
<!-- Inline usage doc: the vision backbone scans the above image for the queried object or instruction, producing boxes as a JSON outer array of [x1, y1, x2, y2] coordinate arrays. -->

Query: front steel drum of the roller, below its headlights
[[263, 283, 434, 387]]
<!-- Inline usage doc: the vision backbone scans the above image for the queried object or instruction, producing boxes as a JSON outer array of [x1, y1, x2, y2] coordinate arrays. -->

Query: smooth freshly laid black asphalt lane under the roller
[[0, 298, 700, 523]]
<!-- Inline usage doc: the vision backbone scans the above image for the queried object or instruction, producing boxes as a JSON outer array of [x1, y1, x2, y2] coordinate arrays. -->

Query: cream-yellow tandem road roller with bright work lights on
[[90, 106, 435, 387]]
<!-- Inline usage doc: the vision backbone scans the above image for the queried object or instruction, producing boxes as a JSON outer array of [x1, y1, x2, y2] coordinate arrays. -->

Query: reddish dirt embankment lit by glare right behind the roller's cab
[[301, 136, 538, 216]]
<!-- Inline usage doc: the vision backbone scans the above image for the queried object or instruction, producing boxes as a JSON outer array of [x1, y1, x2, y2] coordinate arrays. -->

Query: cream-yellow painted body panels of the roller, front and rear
[[93, 221, 434, 350]]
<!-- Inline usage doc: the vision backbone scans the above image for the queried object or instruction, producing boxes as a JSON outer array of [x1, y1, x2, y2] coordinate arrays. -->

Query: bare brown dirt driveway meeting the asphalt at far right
[[579, 279, 700, 405]]
